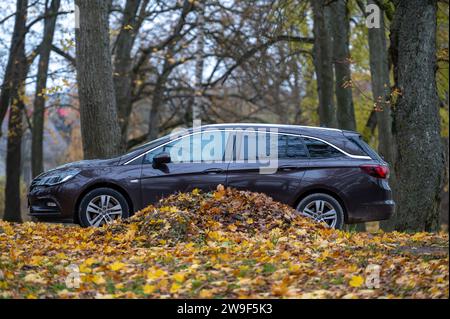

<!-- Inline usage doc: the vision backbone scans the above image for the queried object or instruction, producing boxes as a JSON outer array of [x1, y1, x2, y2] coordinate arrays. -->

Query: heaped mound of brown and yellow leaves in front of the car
[[96, 185, 326, 247]]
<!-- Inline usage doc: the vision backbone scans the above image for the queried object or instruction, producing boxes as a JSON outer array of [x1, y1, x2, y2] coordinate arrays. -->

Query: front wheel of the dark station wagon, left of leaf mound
[[78, 187, 130, 227]]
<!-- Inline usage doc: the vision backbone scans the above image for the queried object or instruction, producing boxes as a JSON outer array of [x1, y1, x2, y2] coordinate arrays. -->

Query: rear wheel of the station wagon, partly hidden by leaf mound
[[296, 193, 344, 229]]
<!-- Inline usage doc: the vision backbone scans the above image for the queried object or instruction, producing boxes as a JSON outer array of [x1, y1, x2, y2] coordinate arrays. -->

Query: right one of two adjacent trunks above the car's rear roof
[[330, 0, 356, 131]]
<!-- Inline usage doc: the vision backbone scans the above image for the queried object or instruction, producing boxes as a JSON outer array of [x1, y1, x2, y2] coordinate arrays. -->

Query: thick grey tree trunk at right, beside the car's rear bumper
[[390, 0, 444, 231]]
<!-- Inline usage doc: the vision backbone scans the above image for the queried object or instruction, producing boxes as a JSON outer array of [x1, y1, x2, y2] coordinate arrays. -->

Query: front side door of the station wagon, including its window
[[140, 130, 230, 206]]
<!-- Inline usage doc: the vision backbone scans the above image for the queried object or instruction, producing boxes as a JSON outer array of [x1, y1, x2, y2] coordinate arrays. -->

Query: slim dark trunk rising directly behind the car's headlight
[[31, 0, 61, 177]]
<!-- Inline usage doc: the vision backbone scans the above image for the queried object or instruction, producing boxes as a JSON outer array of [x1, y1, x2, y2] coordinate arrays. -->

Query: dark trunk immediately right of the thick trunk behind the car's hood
[[114, 0, 148, 149]]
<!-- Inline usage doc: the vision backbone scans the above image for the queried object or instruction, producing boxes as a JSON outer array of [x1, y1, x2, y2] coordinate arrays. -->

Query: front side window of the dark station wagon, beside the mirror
[[144, 131, 229, 164]]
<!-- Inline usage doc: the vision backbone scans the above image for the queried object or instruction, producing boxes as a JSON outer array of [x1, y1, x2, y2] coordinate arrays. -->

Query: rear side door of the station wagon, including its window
[[227, 132, 309, 205]]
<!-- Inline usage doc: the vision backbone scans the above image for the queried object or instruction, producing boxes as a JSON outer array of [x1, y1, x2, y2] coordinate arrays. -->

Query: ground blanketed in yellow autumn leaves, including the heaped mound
[[0, 186, 449, 298]]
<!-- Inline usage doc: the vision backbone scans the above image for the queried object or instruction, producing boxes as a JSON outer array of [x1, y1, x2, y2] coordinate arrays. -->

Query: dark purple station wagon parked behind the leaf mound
[[28, 124, 395, 228]]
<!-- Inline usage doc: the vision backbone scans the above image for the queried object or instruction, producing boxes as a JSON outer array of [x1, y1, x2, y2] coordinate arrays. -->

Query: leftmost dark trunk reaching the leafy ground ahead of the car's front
[[2, 0, 28, 222]]
